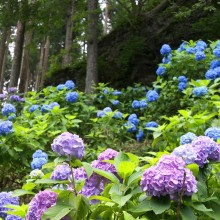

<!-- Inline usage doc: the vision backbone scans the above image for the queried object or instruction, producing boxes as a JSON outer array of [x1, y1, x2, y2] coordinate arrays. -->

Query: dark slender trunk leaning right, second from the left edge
[[9, 21, 25, 87]]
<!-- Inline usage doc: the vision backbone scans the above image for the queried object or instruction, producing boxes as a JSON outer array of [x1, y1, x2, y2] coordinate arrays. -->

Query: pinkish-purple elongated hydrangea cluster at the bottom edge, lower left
[[26, 190, 57, 220]]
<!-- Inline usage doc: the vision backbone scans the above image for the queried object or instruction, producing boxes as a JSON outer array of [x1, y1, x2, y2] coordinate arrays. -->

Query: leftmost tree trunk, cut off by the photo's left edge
[[0, 28, 11, 93]]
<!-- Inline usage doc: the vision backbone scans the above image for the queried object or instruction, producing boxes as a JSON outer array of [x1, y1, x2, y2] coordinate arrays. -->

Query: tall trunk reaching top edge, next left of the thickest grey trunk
[[62, 0, 75, 67]]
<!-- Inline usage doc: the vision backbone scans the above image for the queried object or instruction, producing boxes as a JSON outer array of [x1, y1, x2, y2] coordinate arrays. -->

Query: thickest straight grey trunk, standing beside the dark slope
[[85, 0, 98, 93]]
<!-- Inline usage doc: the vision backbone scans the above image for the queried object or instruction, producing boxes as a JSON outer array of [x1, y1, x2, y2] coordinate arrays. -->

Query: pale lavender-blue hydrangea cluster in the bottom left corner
[[0, 192, 19, 219]]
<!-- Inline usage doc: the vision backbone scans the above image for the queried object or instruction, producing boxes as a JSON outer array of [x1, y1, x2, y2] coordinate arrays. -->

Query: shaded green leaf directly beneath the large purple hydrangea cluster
[[150, 196, 171, 215]]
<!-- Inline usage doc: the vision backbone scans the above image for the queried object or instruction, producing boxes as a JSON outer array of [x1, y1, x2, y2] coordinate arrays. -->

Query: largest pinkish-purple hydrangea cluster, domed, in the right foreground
[[140, 155, 197, 199]]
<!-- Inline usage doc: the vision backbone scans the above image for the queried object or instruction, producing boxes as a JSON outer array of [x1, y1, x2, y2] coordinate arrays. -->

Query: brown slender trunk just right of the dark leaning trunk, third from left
[[19, 30, 33, 93]]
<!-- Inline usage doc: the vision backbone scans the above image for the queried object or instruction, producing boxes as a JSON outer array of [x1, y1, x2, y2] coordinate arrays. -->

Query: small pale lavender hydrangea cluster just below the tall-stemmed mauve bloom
[[50, 164, 71, 180]]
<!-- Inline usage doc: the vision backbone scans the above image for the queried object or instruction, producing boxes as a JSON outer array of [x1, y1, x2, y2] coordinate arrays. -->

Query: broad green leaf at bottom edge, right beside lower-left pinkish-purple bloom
[[42, 204, 73, 220]]
